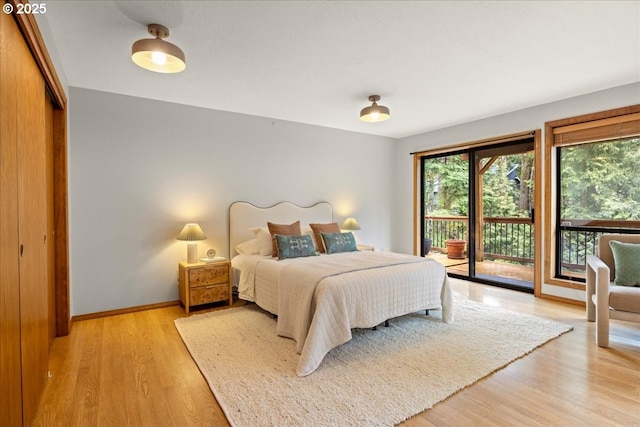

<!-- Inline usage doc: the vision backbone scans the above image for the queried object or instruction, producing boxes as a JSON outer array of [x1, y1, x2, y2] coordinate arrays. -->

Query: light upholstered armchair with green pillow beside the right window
[[587, 234, 640, 347]]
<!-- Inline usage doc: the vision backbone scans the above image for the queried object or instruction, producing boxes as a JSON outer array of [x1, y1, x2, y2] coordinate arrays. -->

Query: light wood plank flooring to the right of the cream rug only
[[403, 281, 640, 426]]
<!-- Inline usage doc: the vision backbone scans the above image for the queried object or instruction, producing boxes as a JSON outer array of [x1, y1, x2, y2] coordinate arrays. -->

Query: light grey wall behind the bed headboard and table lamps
[[69, 87, 396, 315]]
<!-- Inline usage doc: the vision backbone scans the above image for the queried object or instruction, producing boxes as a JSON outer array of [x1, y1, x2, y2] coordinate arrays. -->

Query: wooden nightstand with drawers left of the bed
[[178, 261, 233, 314]]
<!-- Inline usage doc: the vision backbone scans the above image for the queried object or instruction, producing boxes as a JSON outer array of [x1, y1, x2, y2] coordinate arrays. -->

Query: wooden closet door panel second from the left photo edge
[[16, 18, 49, 423]]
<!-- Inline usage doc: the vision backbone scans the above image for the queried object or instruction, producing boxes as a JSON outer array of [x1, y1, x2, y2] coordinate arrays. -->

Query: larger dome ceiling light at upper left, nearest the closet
[[131, 24, 186, 73]]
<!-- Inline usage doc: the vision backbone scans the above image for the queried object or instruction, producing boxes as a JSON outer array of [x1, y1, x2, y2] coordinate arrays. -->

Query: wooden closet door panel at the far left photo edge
[[0, 13, 24, 426]]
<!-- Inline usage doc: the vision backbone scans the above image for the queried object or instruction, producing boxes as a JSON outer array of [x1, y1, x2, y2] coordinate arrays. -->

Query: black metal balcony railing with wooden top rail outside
[[425, 215, 640, 278]]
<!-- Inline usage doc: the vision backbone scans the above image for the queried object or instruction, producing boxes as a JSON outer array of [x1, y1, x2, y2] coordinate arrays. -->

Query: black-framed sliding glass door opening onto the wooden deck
[[421, 136, 535, 292]]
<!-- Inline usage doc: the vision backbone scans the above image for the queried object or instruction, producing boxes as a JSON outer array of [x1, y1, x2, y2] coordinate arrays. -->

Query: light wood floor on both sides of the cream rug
[[34, 281, 640, 427]]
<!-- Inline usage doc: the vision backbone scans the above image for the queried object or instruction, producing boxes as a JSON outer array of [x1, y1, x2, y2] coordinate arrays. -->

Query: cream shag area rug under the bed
[[175, 297, 572, 427]]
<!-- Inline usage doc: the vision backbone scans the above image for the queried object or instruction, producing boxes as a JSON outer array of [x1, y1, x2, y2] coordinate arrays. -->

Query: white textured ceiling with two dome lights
[[41, 0, 640, 138]]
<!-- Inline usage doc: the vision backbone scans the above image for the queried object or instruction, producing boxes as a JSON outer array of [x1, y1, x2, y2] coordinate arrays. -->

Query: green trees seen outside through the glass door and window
[[423, 137, 640, 269]]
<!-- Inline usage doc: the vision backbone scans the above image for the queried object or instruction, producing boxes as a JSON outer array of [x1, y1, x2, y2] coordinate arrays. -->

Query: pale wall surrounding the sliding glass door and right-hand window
[[392, 83, 640, 300]]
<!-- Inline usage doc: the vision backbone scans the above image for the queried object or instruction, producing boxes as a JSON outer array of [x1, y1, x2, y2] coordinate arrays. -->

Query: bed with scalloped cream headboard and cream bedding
[[229, 202, 453, 376]]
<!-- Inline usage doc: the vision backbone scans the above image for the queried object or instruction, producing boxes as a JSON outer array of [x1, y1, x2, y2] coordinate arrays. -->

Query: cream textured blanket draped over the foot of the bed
[[277, 251, 453, 376]]
